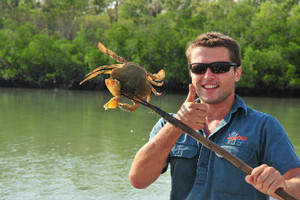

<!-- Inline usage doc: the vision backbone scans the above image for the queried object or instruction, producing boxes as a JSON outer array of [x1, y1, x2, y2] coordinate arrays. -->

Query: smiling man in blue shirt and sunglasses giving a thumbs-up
[[129, 32, 300, 200]]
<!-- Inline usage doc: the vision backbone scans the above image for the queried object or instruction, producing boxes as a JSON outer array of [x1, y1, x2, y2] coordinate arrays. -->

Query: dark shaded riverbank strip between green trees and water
[[0, 78, 300, 98]]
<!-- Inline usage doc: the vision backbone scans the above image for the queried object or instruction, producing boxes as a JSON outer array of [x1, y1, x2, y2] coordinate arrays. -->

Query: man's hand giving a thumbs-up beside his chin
[[175, 84, 207, 130]]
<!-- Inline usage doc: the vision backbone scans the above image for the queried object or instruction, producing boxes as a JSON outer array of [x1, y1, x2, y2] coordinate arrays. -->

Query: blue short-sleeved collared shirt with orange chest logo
[[150, 95, 300, 200]]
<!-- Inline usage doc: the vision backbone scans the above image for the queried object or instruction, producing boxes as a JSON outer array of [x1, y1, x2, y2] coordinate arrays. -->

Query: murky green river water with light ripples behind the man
[[0, 88, 300, 200]]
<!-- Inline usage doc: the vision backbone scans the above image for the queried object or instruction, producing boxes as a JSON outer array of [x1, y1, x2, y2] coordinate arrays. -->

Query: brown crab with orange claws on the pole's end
[[79, 42, 165, 112]]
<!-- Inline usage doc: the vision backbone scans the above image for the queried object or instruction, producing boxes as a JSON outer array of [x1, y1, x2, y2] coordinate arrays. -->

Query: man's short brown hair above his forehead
[[186, 32, 241, 66]]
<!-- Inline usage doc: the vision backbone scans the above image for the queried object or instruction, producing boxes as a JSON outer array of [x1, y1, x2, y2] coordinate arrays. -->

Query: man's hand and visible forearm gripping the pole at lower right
[[245, 164, 300, 199]]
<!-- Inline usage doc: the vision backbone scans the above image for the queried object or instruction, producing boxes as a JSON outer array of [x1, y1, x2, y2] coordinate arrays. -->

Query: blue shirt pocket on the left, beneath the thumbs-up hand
[[170, 134, 199, 158]]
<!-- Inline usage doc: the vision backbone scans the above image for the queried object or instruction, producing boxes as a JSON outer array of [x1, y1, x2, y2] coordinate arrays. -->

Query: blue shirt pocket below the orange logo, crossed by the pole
[[213, 145, 257, 195]]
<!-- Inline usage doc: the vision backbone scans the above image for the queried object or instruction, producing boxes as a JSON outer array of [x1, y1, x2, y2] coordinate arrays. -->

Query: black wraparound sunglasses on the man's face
[[190, 62, 238, 74]]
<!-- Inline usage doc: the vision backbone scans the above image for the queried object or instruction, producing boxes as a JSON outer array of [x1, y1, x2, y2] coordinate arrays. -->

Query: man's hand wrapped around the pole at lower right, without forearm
[[245, 164, 286, 199]]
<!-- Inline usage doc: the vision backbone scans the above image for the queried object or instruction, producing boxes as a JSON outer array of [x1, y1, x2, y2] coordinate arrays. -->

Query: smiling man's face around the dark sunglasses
[[190, 47, 242, 104]]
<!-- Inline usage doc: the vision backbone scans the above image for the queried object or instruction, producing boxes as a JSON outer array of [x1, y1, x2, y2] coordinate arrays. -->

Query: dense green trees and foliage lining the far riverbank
[[0, 0, 300, 88]]
